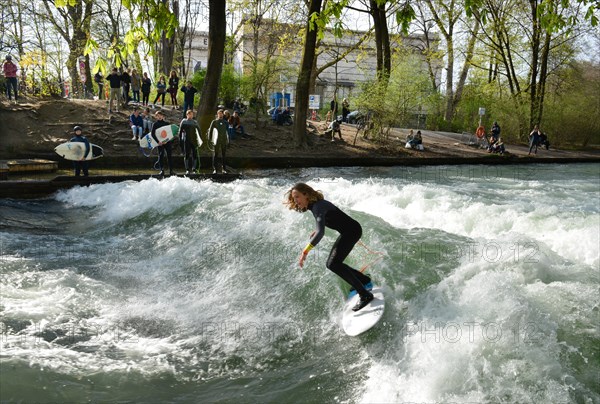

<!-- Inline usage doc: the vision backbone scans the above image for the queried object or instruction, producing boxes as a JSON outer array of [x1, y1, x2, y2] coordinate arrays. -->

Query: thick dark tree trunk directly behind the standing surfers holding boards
[[198, 0, 226, 136]]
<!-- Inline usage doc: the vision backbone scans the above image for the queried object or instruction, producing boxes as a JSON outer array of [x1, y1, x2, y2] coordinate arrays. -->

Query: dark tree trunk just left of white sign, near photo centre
[[293, 0, 323, 147]]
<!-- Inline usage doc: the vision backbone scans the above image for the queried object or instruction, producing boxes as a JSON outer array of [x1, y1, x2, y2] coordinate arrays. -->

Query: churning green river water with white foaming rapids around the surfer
[[0, 164, 600, 403]]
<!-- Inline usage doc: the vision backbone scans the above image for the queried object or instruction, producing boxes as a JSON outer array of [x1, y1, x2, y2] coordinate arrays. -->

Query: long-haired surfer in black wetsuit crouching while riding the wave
[[286, 183, 373, 311]]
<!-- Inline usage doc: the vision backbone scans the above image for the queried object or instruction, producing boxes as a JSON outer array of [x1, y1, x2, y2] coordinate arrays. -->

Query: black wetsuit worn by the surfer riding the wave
[[308, 200, 371, 297]]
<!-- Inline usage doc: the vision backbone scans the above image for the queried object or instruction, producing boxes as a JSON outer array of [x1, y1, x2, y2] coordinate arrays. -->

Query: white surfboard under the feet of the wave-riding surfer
[[342, 287, 385, 337]]
